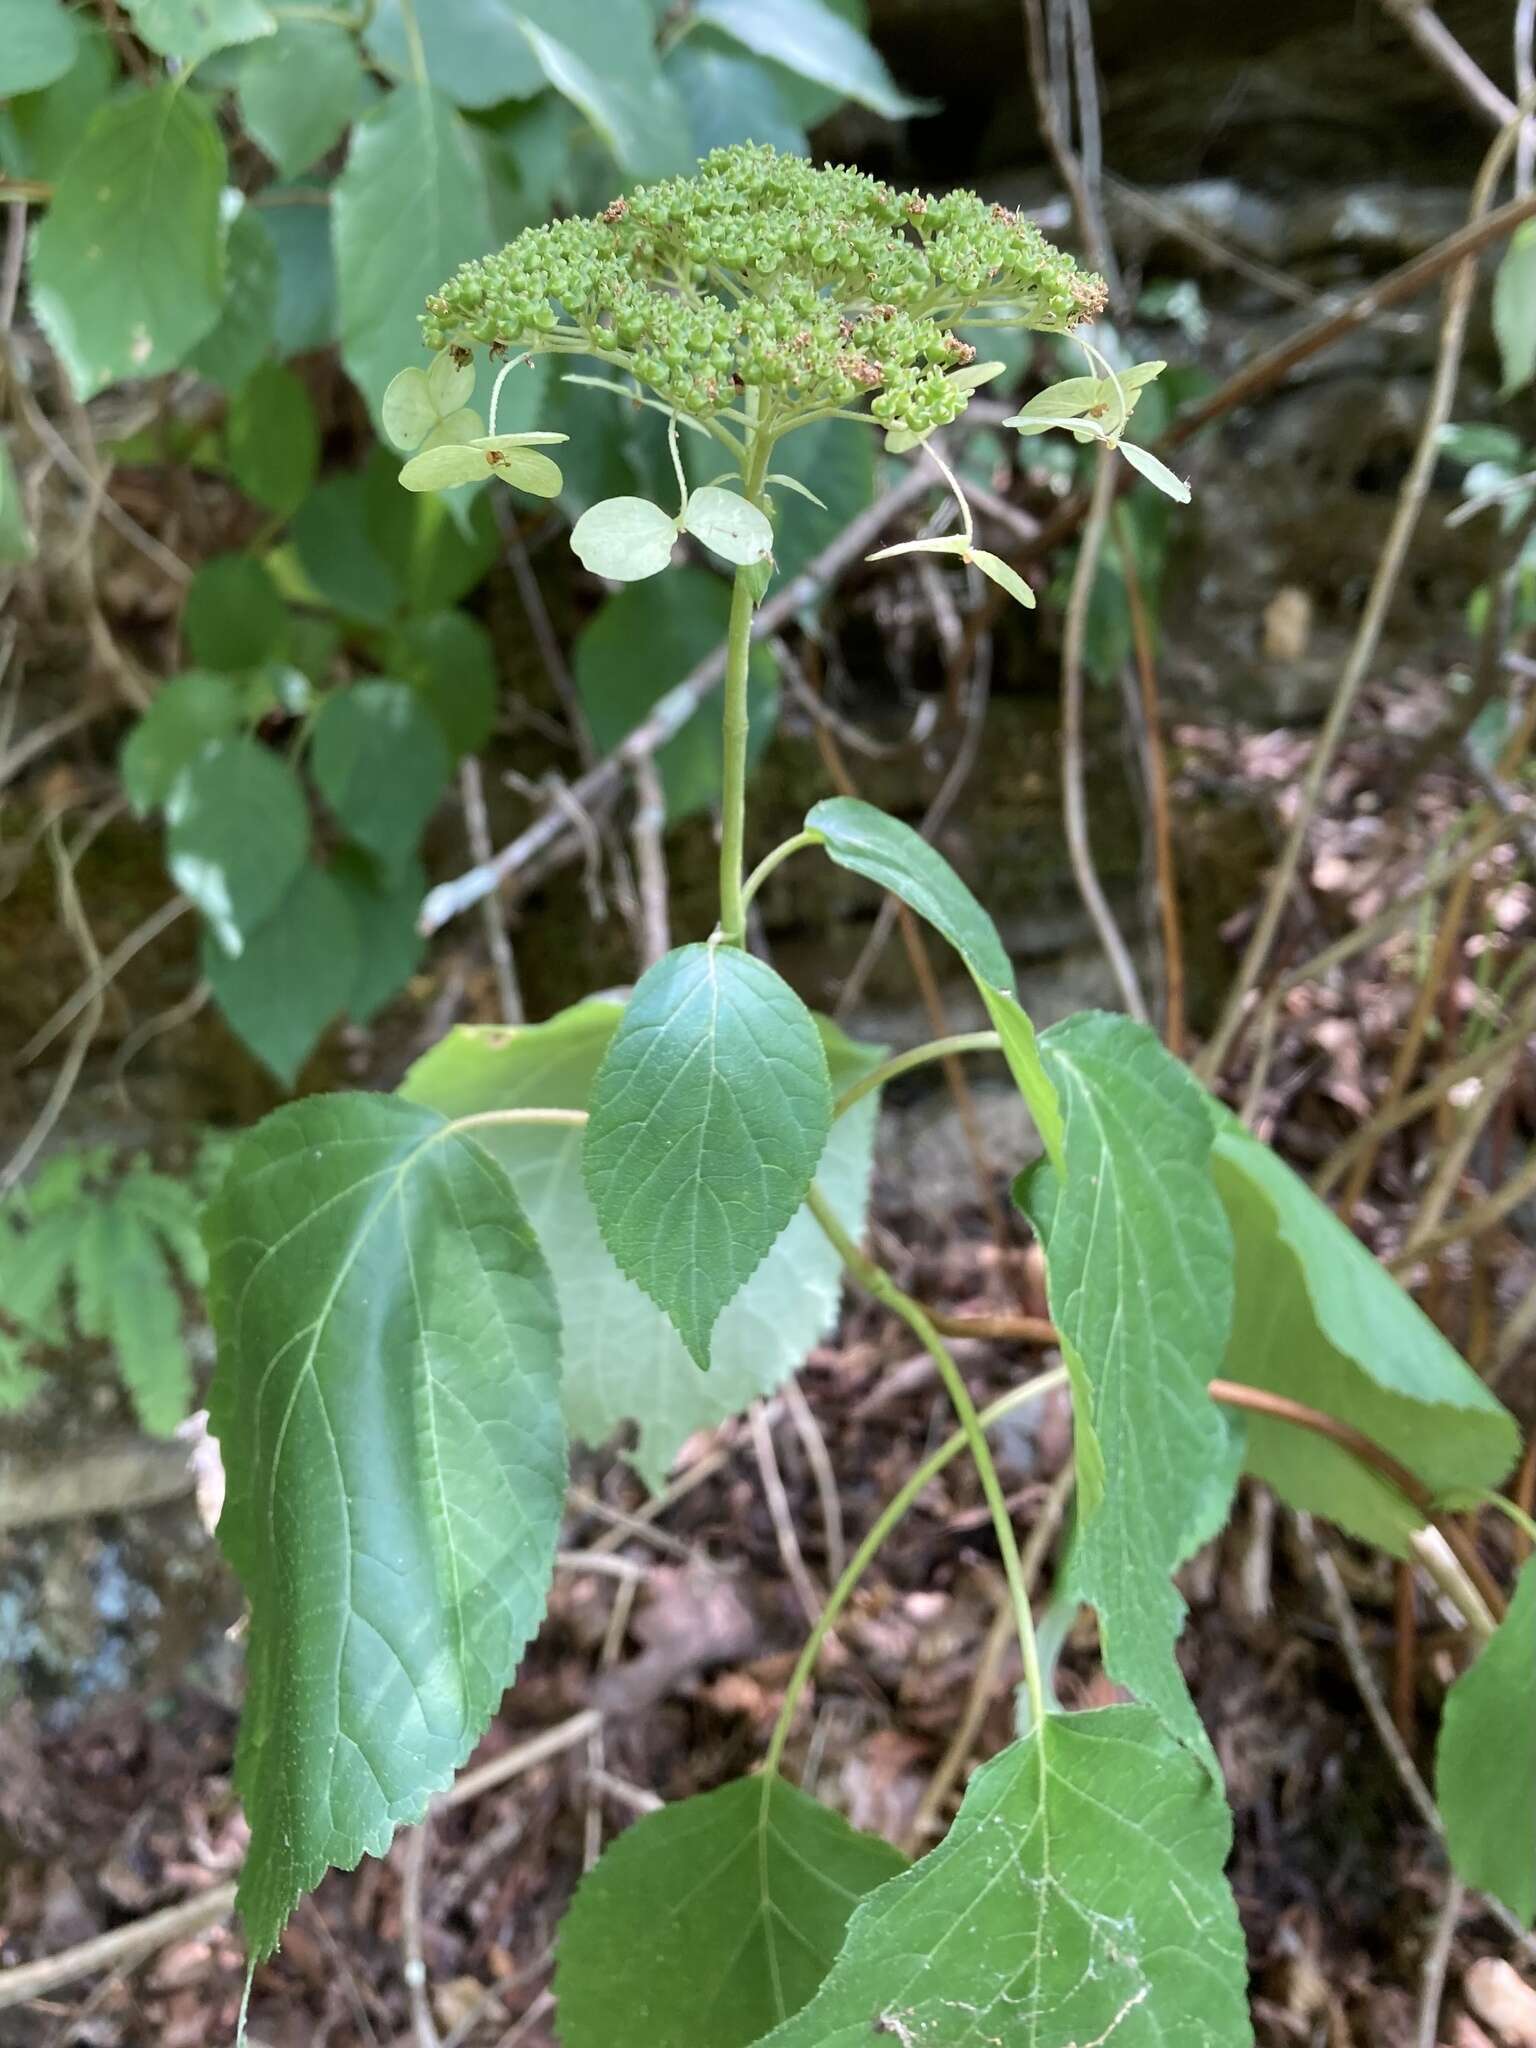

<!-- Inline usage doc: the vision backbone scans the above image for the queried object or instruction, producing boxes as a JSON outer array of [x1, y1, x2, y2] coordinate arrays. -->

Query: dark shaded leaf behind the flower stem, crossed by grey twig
[[571, 565, 778, 821]]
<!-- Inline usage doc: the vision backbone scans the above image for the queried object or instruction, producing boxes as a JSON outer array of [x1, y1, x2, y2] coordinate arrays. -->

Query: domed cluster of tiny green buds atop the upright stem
[[422, 143, 1104, 432]]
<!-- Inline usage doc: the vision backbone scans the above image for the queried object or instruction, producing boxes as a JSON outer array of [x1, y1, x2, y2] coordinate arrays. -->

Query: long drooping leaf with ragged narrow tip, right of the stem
[[1018, 1012, 1237, 1745]]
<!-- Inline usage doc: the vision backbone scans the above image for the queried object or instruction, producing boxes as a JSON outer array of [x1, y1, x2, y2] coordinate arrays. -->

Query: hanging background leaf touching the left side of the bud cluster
[[332, 81, 494, 418]]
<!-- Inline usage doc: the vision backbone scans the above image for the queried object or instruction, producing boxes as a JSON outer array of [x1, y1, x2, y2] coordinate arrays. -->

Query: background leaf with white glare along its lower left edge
[[166, 739, 309, 954]]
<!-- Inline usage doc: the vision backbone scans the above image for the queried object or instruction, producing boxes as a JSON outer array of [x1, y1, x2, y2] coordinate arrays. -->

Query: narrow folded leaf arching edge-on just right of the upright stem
[[805, 797, 1061, 1161]]
